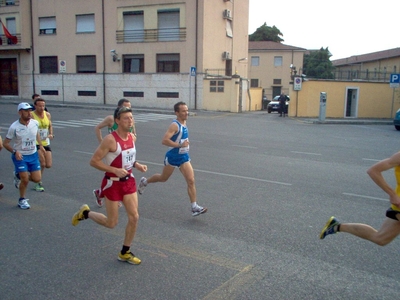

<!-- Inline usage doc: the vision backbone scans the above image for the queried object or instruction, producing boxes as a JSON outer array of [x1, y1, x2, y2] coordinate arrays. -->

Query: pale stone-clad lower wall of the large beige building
[[21, 74, 203, 109]]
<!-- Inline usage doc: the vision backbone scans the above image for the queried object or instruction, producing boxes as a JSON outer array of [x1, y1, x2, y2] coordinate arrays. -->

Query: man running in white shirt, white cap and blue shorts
[[4, 102, 44, 209]]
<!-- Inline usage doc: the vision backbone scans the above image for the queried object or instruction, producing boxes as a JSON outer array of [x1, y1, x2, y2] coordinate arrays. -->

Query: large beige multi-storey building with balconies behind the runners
[[0, 0, 250, 112]]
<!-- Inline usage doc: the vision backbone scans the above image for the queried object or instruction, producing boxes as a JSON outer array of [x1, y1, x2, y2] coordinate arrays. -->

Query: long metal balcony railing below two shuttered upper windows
[[117, 28, 186, 43]]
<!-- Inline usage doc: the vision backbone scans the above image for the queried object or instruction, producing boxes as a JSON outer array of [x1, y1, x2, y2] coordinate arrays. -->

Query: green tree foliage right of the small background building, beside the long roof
[[303, 47, 334, 79]]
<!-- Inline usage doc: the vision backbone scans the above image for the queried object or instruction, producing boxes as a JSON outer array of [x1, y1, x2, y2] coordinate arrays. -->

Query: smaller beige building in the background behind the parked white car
[[248, 41, 307, 100]]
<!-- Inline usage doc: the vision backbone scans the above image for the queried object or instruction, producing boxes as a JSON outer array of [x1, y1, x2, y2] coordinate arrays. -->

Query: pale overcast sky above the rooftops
[[249, 0, 400, 60]]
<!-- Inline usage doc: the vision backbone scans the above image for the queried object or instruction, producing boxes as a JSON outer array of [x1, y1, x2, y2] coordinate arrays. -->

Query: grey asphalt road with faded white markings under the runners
[[0, 104, 400, 300]]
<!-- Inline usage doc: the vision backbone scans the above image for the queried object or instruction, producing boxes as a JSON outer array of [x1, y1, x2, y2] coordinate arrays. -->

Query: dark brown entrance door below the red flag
[[0, 58, 18, 96]]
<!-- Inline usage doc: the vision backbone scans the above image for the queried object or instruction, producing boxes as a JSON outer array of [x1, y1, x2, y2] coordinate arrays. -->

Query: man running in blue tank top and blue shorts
[[138, 102, 207, 217]]
